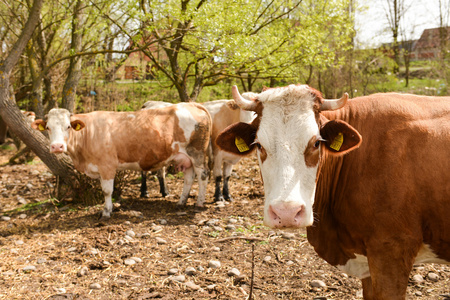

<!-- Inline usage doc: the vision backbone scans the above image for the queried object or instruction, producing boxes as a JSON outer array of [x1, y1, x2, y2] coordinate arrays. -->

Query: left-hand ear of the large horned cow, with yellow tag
[[216, 122, 256, 156]]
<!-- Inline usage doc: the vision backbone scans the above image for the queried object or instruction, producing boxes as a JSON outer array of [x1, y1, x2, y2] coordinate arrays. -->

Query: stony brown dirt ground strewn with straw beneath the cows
[[0, 147, 450, 300]]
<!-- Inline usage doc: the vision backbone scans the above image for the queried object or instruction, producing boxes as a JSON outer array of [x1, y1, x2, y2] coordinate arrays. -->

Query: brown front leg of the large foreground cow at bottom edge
[[364, 241, 420, 300]]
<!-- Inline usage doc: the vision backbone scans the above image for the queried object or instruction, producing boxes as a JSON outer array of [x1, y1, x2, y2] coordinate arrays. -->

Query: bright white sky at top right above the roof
[[356, 0, 450, 48]]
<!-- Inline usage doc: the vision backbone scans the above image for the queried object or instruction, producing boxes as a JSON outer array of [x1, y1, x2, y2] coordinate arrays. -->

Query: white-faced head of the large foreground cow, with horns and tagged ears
[[216, 85, 361, 228]]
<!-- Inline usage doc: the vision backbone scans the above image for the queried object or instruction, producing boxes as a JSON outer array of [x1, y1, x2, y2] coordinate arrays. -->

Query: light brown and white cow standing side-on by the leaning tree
[[32, 103, 211, 218]]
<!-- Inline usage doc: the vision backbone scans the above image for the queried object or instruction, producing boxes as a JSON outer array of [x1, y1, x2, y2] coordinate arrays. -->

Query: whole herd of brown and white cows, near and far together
[[0, 85, 450, 299]]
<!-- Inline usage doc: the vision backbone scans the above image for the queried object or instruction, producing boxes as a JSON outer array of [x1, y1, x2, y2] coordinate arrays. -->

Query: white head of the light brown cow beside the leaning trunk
[[31, 108, 85, 153]]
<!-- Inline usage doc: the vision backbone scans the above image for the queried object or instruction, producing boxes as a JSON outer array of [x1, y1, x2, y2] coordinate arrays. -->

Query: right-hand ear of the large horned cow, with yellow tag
[[320, 120, 362, 155]]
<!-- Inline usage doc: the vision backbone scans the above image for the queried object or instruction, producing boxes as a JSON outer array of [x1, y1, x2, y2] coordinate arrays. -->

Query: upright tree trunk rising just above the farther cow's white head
[[62, 0, 83, 112]]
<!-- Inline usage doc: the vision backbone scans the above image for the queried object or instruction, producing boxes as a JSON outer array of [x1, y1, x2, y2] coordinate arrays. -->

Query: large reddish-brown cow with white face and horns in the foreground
[[216, 85, 450, 300]]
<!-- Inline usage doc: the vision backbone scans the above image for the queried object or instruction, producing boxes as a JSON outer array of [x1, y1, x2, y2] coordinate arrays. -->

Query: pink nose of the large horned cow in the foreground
[[267, 203, 305, 228]]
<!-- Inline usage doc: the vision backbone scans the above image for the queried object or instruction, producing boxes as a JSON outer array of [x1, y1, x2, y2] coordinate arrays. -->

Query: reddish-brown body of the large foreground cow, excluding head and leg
[[308, 93, 450, 284]]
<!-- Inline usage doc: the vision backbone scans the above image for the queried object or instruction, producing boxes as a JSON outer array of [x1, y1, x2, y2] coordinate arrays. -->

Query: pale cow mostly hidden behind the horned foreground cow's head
[[203, 98, 254, 201]]
